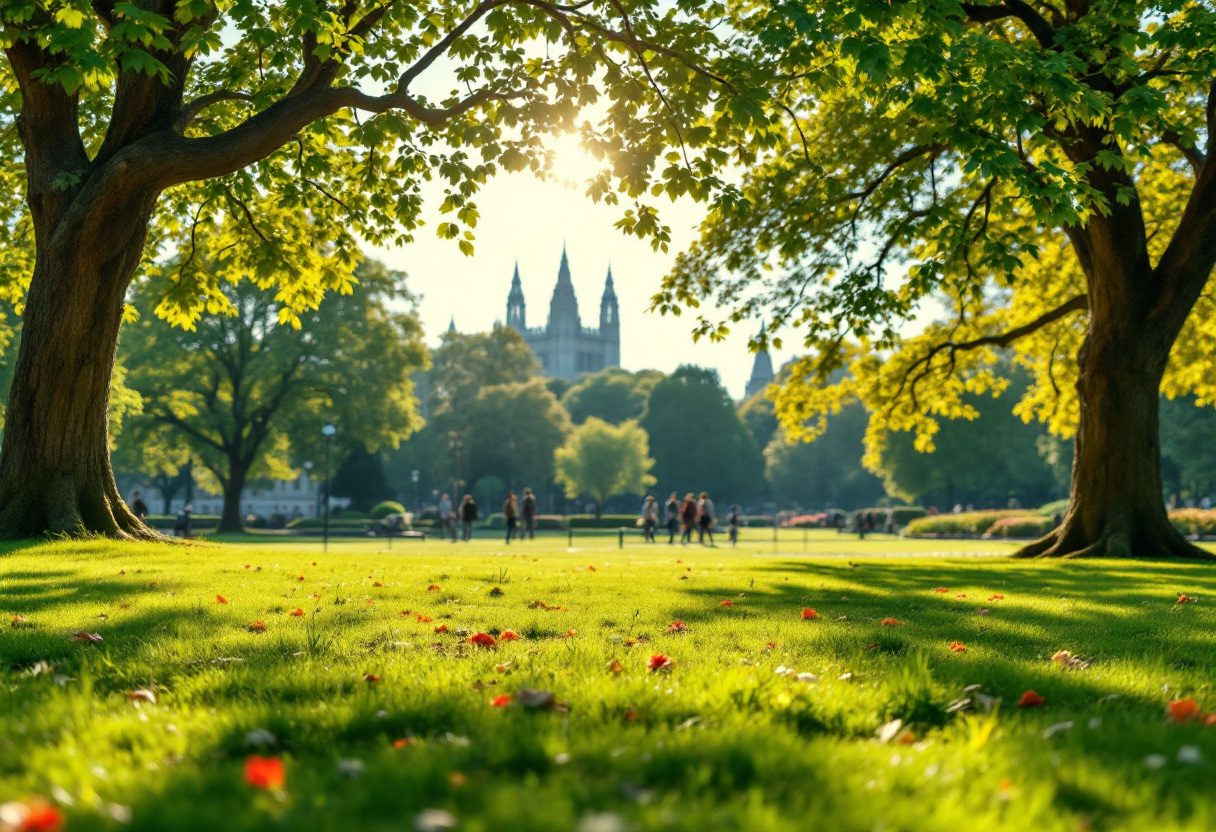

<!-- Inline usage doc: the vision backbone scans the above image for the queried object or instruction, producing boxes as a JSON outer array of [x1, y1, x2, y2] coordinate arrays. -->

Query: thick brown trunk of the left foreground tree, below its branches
[[0, 186, 161, 539]]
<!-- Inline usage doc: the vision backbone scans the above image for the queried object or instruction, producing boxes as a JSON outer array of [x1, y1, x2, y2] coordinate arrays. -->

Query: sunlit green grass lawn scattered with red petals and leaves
[[0, 530, 1216, 832]]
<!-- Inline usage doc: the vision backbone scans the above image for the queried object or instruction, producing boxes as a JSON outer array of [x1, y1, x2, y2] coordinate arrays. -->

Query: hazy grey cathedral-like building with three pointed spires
[[507, 247, 620, 380]]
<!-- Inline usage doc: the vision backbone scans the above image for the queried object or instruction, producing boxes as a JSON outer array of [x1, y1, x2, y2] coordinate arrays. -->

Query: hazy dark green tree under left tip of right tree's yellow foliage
[[764, 401, 886, 511]]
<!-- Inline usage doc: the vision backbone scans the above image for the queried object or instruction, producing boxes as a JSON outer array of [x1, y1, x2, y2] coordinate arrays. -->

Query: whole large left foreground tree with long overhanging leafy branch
[[0, 0, 733, 538]]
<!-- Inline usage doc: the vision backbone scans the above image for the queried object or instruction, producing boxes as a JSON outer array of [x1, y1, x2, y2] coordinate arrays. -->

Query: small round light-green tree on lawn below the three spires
[[556, 416, 654, 517]]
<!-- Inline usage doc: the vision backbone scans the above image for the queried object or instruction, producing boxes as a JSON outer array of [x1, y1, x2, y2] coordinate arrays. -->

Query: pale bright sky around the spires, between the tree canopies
[[370, 133, 795, 399]]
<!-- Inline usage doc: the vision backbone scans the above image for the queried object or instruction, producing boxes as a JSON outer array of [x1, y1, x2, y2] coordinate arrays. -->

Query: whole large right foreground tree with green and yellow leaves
[[655, 0, 1216, 557]]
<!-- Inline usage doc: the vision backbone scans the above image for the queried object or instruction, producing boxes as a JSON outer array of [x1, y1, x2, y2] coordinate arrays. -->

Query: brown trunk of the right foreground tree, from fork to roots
[[1018, 315, 1212, 558]]
